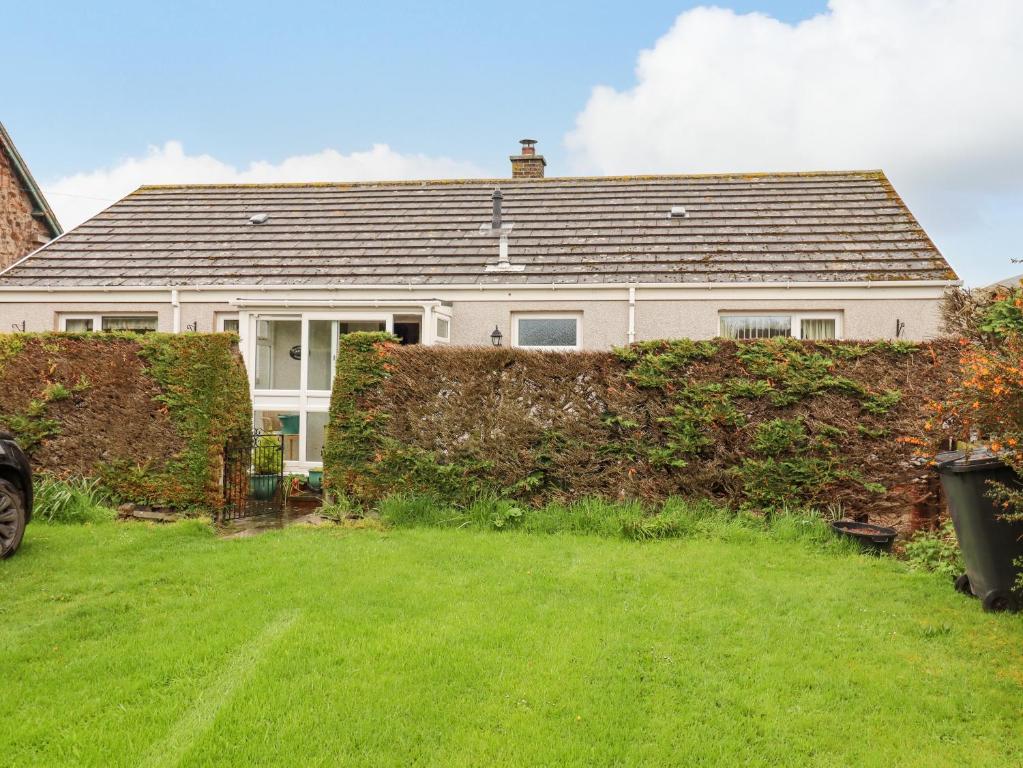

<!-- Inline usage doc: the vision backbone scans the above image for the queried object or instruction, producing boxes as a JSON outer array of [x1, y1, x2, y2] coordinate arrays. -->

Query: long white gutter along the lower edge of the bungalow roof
[[0, 280, 963, 293]]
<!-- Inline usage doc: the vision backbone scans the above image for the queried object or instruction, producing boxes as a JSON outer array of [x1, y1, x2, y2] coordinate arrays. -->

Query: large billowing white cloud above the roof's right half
[[566, 0, 1023, 281]]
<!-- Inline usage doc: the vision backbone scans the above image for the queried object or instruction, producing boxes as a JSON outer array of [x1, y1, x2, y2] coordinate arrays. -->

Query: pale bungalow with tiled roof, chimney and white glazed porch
[[0, 140, 959, 470]]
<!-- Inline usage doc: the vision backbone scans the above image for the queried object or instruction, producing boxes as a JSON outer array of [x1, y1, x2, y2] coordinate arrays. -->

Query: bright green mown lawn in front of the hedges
[[0, 523, 1023, 768]]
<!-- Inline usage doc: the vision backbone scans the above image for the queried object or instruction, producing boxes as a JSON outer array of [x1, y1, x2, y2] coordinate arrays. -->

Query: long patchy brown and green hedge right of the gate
[[325, 340, 959, 523]]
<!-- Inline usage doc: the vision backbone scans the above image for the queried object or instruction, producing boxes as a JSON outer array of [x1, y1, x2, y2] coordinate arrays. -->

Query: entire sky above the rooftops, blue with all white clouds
[[0, 0, 1023, 283]]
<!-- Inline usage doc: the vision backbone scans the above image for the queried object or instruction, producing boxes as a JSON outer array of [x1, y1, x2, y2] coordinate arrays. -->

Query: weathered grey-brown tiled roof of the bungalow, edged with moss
[[0, 171, 958, 287]]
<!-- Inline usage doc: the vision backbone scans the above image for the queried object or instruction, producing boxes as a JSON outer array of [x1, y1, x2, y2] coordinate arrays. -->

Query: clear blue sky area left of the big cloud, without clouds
[[0, 0, 826, 178]]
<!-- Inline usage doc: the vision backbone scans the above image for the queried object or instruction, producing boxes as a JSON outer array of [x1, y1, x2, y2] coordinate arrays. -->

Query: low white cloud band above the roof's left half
[[43, 141, 484, 229]]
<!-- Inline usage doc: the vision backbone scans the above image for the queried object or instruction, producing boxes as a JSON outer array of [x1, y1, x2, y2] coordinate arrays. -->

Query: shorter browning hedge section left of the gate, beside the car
[[0, 333, 252, 509]]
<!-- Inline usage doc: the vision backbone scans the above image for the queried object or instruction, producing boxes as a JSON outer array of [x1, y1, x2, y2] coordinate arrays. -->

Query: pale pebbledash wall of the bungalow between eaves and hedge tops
[[0, 283, 946, 350]]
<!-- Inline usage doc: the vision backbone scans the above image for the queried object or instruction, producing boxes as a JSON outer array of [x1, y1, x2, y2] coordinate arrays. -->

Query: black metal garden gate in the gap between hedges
[[218, 430, 284, 522]]
